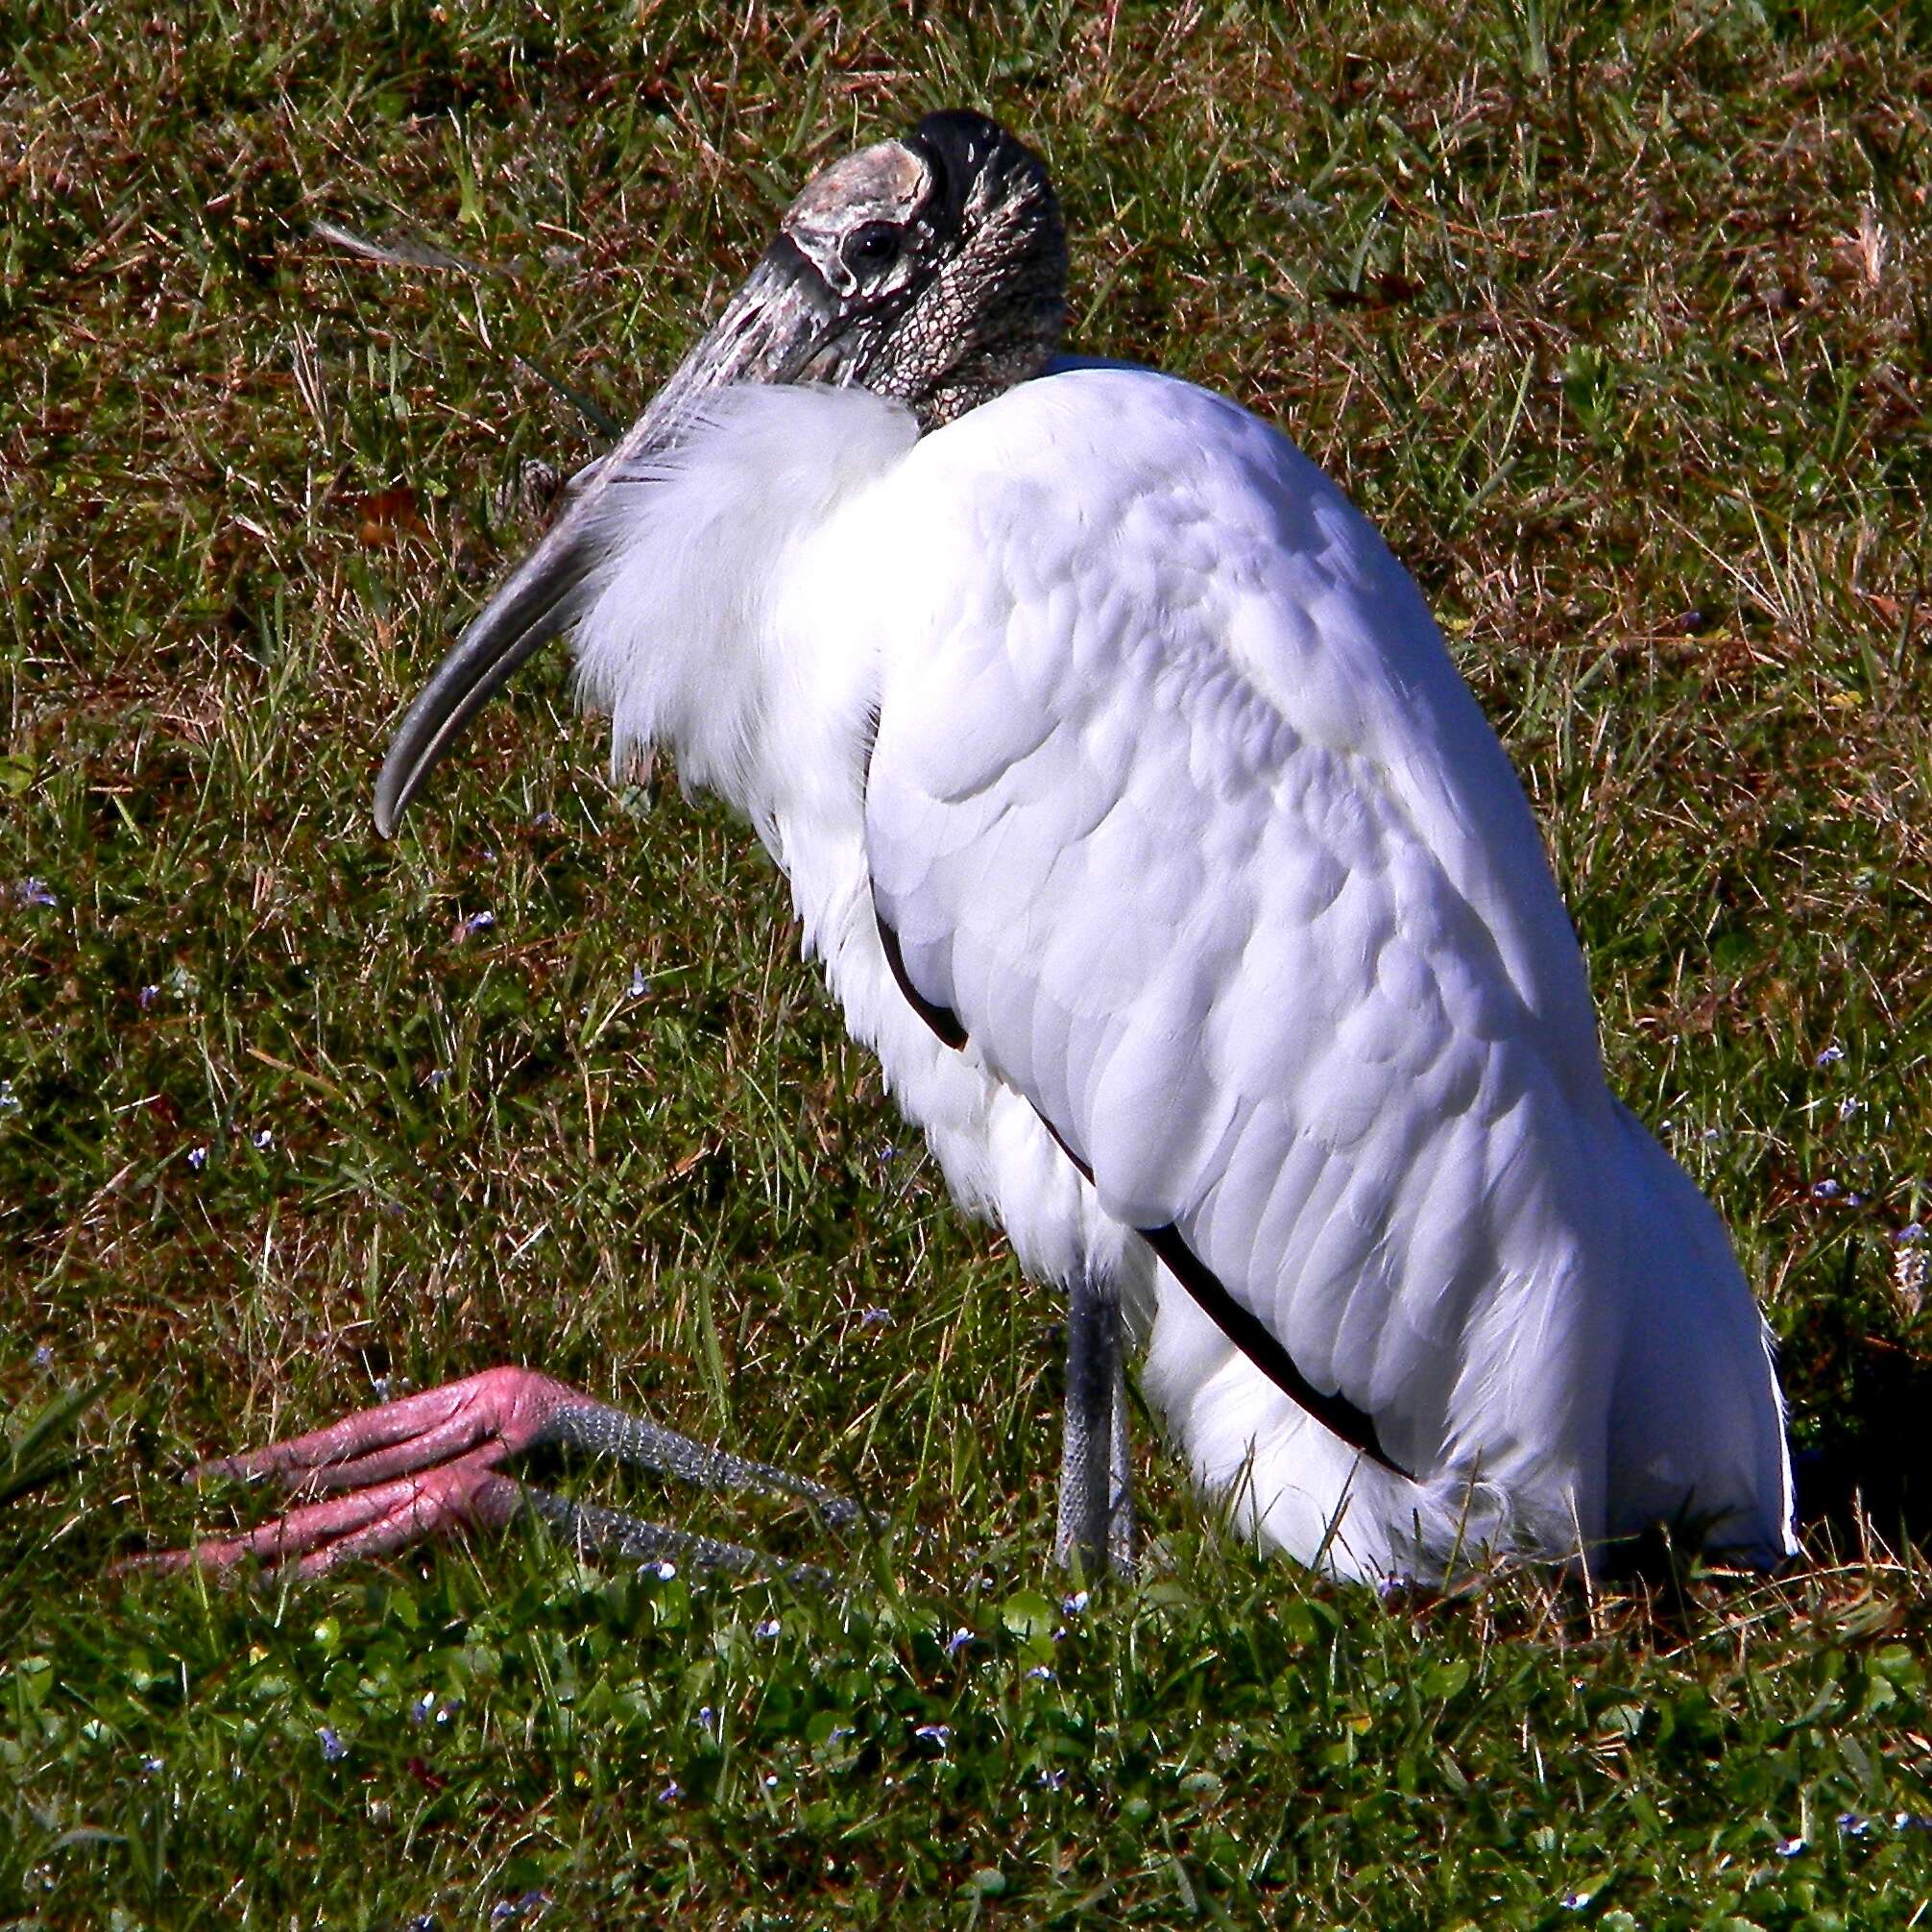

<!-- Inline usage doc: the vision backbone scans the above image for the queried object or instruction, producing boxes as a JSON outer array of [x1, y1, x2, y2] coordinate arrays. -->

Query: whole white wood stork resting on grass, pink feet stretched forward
[[150, 114, 1793, 1579]]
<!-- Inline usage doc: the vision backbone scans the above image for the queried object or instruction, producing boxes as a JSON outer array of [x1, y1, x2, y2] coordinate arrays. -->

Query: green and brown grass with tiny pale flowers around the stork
[[0, 0, 1932, 1928]]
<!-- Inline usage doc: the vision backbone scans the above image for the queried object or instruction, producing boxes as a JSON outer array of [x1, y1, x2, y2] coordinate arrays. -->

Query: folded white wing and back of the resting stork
[[865, 369, 1781, 1560]]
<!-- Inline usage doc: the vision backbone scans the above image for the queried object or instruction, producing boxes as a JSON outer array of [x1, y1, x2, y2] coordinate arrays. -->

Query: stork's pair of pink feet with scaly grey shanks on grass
[[124, 1367, 857, 1581]]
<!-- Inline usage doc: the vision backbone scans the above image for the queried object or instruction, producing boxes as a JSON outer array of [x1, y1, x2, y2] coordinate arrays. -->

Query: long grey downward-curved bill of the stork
[[374, 235, 846, 838]]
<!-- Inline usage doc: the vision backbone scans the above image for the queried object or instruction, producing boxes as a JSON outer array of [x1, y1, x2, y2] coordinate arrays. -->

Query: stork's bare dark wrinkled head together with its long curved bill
[[374, 112, 1067, 838]]
